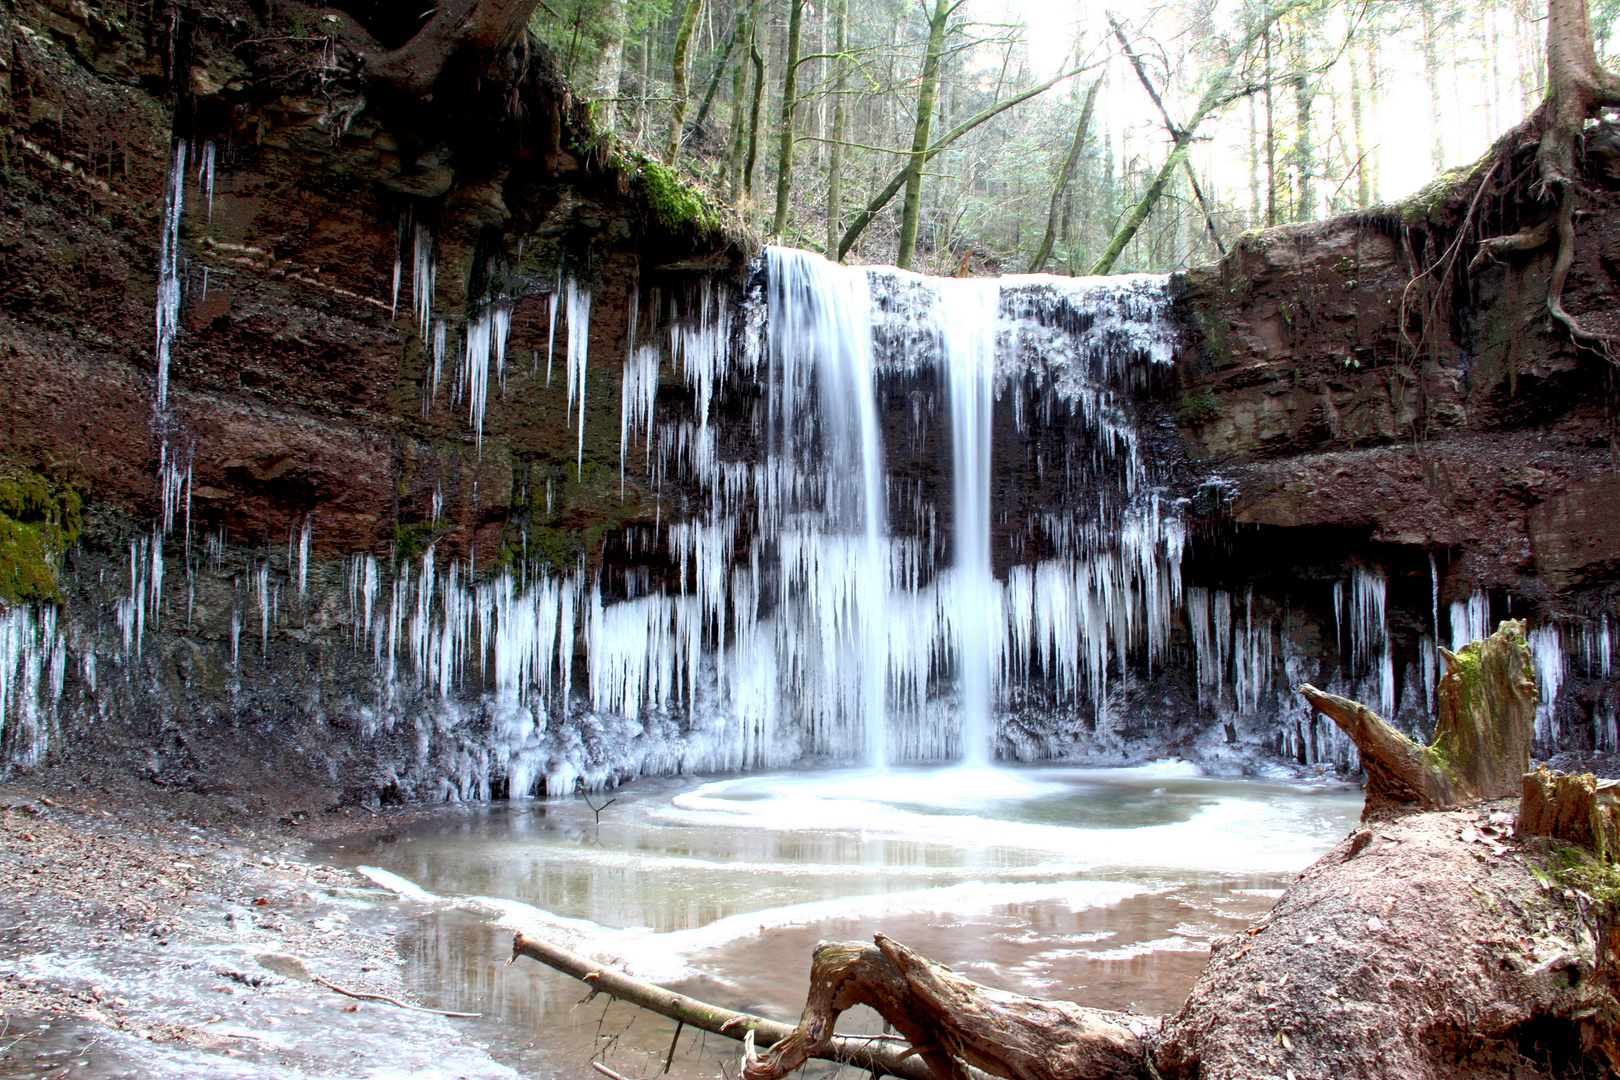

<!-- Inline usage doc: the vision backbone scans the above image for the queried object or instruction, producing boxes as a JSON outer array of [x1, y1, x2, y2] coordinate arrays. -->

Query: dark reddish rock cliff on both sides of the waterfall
[[0, 0, 1620, 805]]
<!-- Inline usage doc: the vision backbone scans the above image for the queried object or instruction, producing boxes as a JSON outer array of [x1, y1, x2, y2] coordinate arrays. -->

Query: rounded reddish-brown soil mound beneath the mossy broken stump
[[1157, 805, 1620, 1080]]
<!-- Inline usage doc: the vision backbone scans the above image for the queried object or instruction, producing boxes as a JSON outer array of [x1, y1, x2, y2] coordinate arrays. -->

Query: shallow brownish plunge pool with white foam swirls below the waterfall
[[319, 763, 1361, 1077]]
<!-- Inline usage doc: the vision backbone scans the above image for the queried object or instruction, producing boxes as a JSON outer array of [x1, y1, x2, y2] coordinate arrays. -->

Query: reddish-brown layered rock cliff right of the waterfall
[[1179, 153, 1620, 753]]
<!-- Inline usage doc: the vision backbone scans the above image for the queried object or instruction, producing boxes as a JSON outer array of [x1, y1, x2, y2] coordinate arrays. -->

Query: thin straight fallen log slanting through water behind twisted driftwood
[[507, 931, 936, 1080]]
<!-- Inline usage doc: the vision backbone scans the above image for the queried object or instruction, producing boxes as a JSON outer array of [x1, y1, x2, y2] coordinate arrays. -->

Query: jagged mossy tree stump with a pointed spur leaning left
[[1298, 620, 1541, 810]]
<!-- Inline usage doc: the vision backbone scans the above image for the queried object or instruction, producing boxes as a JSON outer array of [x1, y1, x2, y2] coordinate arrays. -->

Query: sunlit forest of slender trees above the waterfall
[[530, 0, 1620, 274]]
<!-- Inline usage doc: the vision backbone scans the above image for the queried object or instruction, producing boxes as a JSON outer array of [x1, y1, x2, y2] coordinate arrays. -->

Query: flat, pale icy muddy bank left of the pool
[[0, 782, 515, 1077]]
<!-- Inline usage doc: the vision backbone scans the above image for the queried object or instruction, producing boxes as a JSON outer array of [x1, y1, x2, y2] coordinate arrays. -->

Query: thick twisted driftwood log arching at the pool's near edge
[[742, 934, 1157, 1080]]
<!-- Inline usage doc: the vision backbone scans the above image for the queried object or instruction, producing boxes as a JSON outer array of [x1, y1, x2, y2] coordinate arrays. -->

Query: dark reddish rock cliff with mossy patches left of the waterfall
[[0, 2, 745, 798]]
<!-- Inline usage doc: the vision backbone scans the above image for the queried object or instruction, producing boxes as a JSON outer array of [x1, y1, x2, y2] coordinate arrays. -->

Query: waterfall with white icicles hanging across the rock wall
[[9, 208, 1620, 797]]
